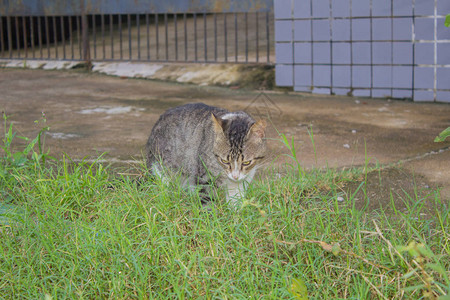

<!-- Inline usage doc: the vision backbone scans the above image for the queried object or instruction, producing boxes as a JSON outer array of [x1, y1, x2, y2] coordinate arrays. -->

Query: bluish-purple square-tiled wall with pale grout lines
[[274, 0, 450, 102]]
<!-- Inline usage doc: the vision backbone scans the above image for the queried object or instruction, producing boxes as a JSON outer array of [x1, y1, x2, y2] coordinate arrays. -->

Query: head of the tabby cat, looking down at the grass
[[211, 112, 266, 181]]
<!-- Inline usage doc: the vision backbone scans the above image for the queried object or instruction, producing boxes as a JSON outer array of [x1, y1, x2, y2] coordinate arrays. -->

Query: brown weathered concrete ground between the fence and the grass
[[0, 69, 450, 207]]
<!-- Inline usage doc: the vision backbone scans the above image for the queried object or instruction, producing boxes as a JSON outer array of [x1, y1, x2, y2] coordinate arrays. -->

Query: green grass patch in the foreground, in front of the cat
[[0, 121, 450, 299]]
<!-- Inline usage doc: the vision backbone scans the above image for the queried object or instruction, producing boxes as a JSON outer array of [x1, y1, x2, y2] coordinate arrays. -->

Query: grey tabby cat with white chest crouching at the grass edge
[[146, 103, 266, 207]]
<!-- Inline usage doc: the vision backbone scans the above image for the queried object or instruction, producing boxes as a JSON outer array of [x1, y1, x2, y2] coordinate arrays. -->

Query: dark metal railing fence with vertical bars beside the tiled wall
[[0, 0, 274, 64]]
